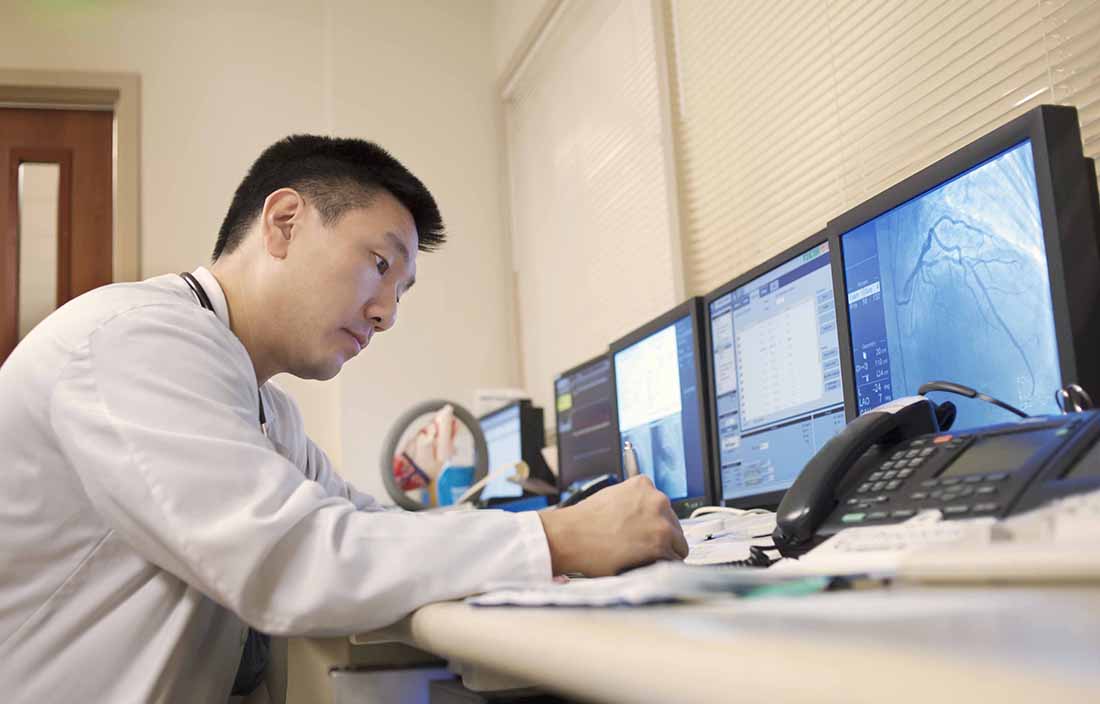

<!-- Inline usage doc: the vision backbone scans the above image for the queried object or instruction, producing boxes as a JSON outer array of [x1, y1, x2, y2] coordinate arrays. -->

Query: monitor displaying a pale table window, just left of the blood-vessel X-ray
[[704, 232, 845, 508]]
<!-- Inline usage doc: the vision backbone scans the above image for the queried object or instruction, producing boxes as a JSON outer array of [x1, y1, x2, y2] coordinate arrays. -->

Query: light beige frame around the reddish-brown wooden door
[[0, 68, 141, 282]]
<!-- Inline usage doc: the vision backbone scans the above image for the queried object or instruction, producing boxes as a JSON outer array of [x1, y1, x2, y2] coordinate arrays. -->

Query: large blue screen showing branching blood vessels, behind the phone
[[840, 140, 1060, 428]]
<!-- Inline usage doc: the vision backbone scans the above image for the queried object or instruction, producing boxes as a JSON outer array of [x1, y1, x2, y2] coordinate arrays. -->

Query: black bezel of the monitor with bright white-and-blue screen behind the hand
[[607, 296, 714, 517]]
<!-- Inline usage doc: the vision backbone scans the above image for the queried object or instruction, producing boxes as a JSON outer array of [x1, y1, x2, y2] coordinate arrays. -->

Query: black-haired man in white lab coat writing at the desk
[[0, 136, 686, 702]]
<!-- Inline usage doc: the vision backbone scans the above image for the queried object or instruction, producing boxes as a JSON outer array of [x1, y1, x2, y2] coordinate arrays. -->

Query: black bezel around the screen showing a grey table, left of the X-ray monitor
[[703, 230, 848, 510]]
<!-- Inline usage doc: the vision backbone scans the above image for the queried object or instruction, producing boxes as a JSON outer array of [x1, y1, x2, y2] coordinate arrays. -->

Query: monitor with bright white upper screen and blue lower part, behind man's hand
[[611, 298, 712, 516]]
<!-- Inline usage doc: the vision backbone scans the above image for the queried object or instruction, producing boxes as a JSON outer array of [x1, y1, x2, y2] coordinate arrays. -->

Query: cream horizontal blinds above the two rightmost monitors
[[670, 0, 1100, 293]]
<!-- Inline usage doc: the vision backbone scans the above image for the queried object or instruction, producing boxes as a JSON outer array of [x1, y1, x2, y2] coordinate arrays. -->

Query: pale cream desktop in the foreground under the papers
[[355, 587, 1100, 704]]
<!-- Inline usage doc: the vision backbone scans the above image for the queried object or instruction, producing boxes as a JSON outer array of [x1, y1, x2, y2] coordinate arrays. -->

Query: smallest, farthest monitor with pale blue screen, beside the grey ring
[[477, 400, 553, 505]]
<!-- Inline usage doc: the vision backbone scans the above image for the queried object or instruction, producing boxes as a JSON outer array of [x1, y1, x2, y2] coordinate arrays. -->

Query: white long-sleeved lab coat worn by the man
[[0, 268, 550, 703]]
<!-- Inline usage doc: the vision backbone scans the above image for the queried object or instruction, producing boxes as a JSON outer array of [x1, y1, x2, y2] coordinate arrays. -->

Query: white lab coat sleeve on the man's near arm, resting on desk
[[51, 305, 550, 636]]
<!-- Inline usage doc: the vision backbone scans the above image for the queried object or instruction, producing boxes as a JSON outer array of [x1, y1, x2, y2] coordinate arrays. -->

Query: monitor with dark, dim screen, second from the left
[[553, 354, 619, 494]]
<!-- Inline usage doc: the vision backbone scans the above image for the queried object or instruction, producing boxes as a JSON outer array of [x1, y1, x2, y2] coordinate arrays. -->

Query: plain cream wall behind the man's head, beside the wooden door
[[0, 0, 518, 493]]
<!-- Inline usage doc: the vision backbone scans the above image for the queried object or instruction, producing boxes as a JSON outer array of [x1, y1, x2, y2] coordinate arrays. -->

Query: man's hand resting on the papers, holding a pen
[[539, 476, 688, 576]]
